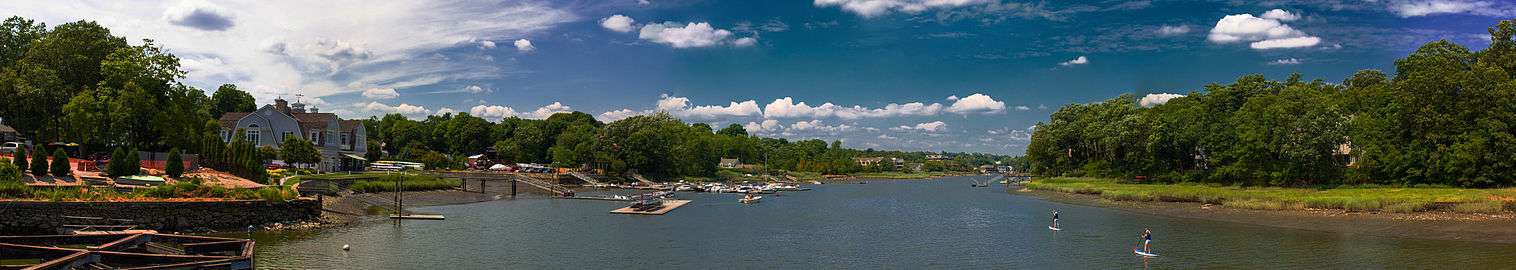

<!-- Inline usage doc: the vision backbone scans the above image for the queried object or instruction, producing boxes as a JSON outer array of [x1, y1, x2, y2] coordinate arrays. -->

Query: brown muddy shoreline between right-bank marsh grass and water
[[1007, 188, 1516, 244]]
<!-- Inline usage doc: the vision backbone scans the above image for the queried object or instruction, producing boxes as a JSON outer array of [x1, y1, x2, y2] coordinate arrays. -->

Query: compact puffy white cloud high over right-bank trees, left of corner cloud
[[1207, 9, 1320, 50]]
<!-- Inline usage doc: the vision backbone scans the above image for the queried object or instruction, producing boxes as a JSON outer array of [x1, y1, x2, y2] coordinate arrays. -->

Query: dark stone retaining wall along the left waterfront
[[0, 199, 321, 235]]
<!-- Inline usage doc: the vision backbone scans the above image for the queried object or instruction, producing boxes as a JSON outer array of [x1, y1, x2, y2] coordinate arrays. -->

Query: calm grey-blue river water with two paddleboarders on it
[[255, 177, 1516, 270]]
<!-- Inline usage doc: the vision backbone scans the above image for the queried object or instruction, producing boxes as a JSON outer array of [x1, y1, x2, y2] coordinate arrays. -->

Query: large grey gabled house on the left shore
[[220, 99, 368, 171]]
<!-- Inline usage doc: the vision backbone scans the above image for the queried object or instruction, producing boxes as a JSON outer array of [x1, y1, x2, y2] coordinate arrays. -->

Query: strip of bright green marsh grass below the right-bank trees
[[1026, 177, 1516, 212]]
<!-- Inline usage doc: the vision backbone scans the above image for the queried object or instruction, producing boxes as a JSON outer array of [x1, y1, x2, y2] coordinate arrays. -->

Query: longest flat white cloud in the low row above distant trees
[[763, 97, 943, 120]]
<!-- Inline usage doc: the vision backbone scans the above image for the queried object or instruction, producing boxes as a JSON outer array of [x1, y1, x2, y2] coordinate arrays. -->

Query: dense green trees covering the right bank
[[1026, 21, 1516, 188]]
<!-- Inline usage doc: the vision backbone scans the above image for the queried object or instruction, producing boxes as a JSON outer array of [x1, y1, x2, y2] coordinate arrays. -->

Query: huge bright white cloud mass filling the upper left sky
[[0, 0, 578, 103]]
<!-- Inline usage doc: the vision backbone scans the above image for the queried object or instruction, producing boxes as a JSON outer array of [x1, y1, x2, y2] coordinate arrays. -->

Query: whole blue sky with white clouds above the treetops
[[0, 0, 1516, 155]]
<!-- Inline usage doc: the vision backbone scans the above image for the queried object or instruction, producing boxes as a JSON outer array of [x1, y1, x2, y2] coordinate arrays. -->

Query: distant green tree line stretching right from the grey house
[[364, 112, 1010, 177]]
